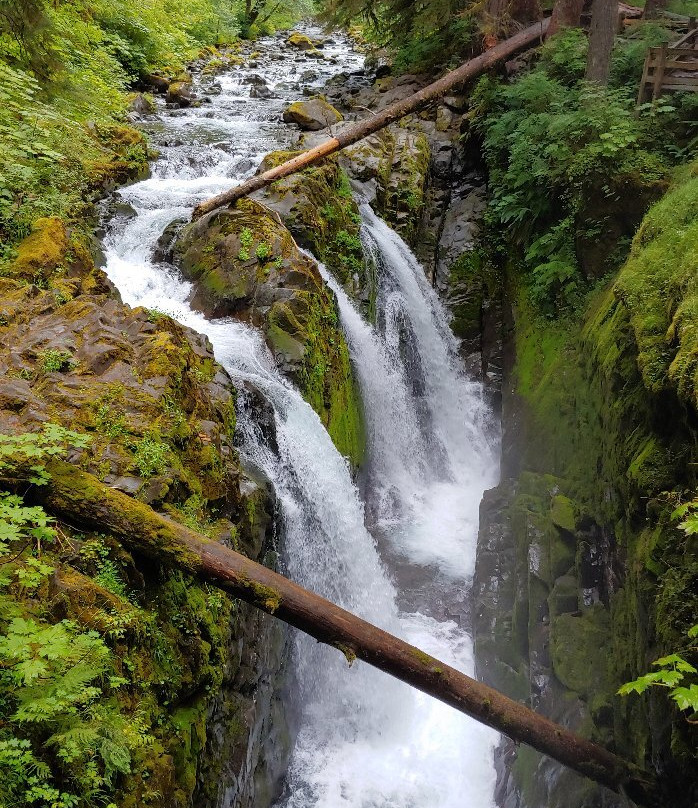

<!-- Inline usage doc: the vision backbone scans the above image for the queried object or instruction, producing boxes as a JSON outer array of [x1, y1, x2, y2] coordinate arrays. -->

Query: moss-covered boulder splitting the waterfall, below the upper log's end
[[175, 199, 363, 464]]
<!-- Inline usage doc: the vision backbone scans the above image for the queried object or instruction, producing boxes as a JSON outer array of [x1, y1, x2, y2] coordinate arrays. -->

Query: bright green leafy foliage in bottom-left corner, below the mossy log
[[0, 617, 150, 805]]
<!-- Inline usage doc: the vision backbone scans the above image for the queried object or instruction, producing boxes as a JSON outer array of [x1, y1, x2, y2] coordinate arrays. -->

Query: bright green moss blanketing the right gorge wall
[[498, 164, 698, 790]]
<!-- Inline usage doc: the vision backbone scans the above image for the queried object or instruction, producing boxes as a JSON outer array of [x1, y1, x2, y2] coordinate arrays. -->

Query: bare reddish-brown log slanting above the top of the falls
[[192, 19, 550, 219]]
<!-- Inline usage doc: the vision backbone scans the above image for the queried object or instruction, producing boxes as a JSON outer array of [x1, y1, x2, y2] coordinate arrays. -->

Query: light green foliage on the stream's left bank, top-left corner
[[0, 0, 243, 260]]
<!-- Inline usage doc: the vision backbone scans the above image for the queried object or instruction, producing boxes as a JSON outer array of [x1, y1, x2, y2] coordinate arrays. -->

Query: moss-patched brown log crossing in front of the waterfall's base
[[27, 461, 661, 808]]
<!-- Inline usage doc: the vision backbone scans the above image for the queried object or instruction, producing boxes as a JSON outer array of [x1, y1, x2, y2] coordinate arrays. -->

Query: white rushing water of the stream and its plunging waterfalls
[[104, 30, 497, 808]]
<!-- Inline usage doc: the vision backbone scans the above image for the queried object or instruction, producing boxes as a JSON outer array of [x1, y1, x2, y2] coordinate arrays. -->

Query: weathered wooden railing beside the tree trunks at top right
[[637, 17, 698, 104]]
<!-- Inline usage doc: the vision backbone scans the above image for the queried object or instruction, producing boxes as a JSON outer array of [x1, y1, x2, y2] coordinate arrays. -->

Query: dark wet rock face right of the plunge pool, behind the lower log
[[472, 473, 622, 808]]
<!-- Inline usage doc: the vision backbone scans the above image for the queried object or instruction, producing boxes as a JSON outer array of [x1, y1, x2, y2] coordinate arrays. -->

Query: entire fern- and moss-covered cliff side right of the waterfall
[[464, 26, 698, 806]]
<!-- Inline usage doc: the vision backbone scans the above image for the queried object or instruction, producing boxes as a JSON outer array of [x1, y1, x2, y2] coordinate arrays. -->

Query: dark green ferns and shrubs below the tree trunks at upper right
[[471, 25, 694, 316]]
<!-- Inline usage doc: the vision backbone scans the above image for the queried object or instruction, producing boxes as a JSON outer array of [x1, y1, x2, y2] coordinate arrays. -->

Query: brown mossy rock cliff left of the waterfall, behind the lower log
[[0, 219, 287, 808]]
